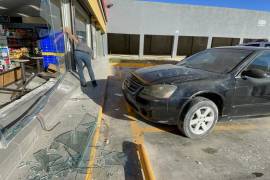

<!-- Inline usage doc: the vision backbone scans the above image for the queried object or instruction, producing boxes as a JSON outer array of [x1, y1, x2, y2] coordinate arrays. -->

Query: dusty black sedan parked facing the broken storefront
[[122, 46, 270, 138]]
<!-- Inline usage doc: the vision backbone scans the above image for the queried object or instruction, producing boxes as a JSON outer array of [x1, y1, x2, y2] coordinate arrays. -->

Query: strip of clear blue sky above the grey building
[[142, 0, 270, 12]]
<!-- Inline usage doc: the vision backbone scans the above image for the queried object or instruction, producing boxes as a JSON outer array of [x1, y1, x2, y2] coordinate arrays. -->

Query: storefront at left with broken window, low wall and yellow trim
[[0, 0, 107, 179]]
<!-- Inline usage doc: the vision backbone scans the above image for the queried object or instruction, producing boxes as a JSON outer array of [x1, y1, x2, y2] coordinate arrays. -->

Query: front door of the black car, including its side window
[[233, 50, 270, 116]]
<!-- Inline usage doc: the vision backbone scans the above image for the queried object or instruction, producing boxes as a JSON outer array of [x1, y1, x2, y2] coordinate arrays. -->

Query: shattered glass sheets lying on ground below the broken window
[[19, 114, 127, 180]]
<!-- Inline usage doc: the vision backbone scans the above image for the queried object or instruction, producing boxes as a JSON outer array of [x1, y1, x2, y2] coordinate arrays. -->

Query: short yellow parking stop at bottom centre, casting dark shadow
[[138, 144, 156, 180]]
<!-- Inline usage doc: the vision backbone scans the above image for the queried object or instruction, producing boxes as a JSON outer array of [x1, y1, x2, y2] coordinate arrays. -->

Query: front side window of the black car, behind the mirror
[[248, 51, 270, 74]]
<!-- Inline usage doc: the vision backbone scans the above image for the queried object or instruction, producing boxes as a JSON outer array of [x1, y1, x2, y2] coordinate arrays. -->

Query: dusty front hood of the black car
[[133, 64, 220, 84]]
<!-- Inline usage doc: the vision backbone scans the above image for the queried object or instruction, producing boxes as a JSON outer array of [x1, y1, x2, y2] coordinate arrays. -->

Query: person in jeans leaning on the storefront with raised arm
[[64, 27, 97, 87]]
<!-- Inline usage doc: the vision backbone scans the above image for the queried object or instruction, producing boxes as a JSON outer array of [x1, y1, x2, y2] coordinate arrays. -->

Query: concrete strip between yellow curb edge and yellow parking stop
[[93, 76, 144, 180]]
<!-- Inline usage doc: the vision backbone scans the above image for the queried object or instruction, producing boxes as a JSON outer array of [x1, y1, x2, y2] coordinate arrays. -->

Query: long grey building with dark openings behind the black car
[[108, 0, 270, 57]]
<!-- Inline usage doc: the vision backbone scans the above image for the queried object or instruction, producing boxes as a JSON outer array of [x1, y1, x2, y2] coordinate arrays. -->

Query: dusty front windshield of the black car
[[178, 48, 253, 73]]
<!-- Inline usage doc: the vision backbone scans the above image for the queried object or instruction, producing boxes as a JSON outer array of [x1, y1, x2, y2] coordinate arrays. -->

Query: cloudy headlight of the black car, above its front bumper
[[141, 84, 177, 98]]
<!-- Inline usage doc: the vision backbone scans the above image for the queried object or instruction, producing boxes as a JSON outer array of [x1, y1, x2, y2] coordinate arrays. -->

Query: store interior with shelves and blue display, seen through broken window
[[0, 0, 65, 108]]
